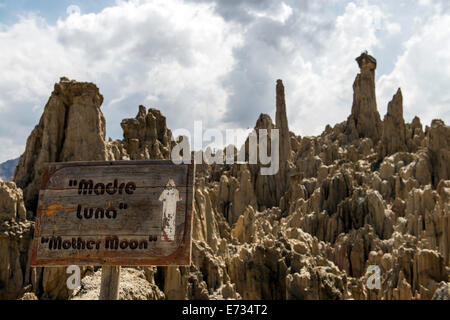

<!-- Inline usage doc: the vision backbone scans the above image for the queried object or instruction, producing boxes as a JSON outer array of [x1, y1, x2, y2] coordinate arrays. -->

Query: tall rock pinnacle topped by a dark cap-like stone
[[347, 52, 382, 143]]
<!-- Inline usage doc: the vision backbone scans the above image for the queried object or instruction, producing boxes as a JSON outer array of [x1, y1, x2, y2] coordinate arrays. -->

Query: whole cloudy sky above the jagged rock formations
[[0, 0, 450, 162]]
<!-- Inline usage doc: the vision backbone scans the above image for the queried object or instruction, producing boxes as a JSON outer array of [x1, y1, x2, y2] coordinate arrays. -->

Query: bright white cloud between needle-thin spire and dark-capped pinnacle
[[285, 3, 385, 135]]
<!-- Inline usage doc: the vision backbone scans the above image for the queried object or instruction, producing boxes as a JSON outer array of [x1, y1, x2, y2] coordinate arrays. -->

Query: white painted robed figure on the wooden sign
[[159, 178, 181, 241]]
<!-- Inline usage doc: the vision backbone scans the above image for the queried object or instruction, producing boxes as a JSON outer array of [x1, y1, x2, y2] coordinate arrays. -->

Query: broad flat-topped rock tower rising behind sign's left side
[[14, 77, 107, 211]]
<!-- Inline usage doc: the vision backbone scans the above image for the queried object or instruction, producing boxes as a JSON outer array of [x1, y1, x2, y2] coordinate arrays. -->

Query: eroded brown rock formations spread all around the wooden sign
[[0, 53, 450, 299]]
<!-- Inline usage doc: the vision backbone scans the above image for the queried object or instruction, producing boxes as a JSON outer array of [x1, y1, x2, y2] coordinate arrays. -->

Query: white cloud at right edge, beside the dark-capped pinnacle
[[377, 10, 450, 125]]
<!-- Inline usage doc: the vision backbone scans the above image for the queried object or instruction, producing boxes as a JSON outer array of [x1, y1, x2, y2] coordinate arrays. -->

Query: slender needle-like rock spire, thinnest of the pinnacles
[[275, 80, 291, 201]]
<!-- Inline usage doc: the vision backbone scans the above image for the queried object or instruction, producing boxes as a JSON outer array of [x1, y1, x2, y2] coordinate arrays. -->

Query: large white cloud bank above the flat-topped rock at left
[[0, 0, 239, 161]]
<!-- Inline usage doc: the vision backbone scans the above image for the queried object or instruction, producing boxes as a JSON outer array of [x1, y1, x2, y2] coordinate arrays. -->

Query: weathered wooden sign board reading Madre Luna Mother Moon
[[31, 160, 195, 266]]
